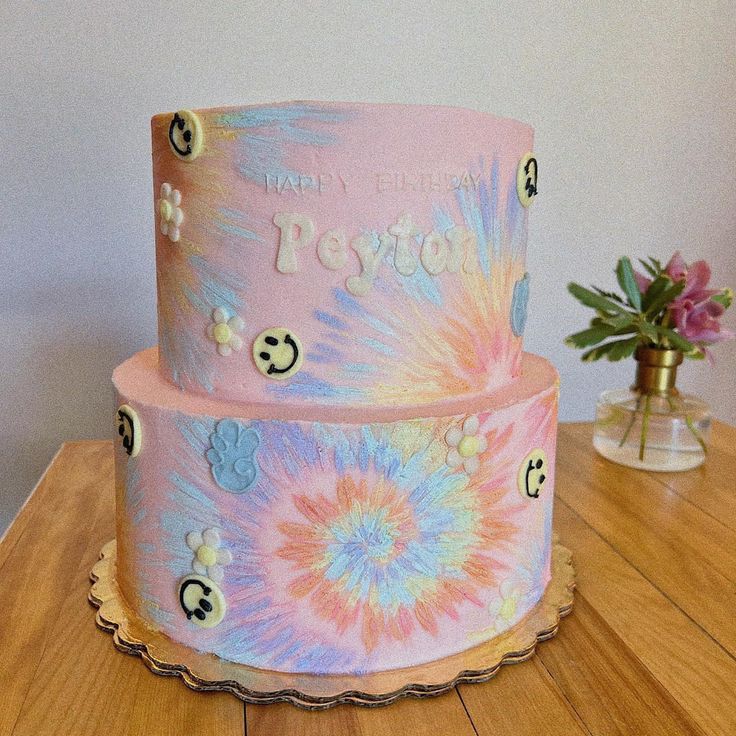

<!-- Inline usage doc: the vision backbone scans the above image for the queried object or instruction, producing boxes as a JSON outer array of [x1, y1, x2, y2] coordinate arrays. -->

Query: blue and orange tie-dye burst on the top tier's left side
[[152, 105, 350, 393]]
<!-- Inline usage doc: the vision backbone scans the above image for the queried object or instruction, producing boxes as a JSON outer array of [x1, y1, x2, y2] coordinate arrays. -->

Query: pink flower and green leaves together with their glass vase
[[565, 251, 734, 470]]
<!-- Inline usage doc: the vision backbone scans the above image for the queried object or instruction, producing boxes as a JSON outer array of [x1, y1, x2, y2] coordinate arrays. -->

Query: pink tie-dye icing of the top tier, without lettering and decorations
[[153, 103, 531, 405]]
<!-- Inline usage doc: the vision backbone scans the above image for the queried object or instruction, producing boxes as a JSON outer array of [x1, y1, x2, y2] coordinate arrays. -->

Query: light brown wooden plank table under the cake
[[0, 424, 736, 736]]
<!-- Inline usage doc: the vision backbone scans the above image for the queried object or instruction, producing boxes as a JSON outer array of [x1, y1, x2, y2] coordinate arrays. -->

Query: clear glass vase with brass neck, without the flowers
[[593, 348, 711, 472]]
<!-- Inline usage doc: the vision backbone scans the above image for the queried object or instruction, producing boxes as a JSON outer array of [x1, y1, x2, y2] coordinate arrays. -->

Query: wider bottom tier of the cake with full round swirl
[[113, 350, 558, 674]]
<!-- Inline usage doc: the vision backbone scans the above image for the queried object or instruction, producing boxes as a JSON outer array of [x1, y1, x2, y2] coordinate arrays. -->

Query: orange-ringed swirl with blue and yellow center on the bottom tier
[[277, 458, 518, 652]]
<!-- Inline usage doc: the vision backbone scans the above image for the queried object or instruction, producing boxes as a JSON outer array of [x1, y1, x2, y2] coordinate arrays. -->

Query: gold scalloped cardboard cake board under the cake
[[89, 540, 575, 710]]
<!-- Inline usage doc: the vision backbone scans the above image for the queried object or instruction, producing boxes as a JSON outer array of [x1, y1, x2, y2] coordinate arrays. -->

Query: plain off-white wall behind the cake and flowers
[[0, 0, 736, 529]]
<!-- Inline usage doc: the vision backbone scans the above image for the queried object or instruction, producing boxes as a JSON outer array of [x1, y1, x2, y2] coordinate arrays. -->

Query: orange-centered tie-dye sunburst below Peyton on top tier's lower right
[[269, 168, 526, 403]]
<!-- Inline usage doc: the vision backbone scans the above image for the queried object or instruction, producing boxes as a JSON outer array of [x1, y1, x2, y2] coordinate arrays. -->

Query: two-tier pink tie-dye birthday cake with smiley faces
[[105, 102, 558, 675]]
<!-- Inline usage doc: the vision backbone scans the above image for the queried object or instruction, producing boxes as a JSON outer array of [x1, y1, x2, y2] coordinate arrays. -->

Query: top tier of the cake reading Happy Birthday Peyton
[[152, 102, 537, 406]]
